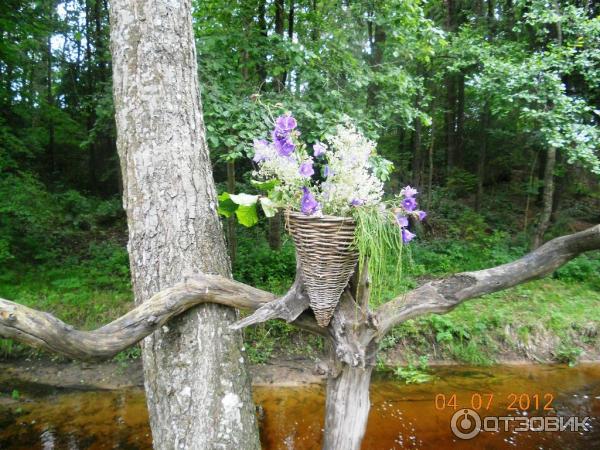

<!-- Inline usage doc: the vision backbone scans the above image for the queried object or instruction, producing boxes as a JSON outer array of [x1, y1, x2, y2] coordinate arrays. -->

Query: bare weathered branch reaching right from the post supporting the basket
[[375, 225, 600, 335]]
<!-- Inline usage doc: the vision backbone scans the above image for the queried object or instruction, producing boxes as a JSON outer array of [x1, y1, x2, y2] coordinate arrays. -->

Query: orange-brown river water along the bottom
[[0, 364, 600, 450]]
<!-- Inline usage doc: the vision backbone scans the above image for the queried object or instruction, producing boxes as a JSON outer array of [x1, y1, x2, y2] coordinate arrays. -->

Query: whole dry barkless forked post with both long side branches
[[0, 225, 600, 450]]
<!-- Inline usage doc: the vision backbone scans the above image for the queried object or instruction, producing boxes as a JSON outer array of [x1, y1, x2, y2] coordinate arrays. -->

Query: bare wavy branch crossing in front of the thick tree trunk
[[0, 274, 323, 359]]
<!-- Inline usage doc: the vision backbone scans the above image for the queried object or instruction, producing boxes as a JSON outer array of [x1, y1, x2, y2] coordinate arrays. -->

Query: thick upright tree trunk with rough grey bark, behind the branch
[[110, 0, 260, 449]]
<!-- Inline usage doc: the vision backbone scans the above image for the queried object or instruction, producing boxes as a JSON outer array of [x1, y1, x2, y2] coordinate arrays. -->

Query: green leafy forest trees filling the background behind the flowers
[[0, 0, 600, 266]]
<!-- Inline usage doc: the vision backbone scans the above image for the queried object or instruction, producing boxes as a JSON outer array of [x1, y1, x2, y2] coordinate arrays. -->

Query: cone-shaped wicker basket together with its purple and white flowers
[[219, 114, 425, 327]]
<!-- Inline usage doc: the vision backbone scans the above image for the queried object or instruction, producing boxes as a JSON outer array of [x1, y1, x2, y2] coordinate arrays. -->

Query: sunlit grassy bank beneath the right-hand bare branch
[[380, 278, 600, 365]]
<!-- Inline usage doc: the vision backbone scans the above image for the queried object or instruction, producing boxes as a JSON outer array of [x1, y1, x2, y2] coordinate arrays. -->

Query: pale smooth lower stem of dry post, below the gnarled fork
[[323, 365, 373, 450]]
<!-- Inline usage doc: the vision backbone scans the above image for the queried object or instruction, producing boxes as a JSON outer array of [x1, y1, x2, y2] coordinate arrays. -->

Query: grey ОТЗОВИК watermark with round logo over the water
[[450, 408, 591, 440]]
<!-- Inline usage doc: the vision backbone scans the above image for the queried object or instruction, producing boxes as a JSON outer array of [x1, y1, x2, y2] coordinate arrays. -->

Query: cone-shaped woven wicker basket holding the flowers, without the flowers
[[286, 211, 358, 327]]
